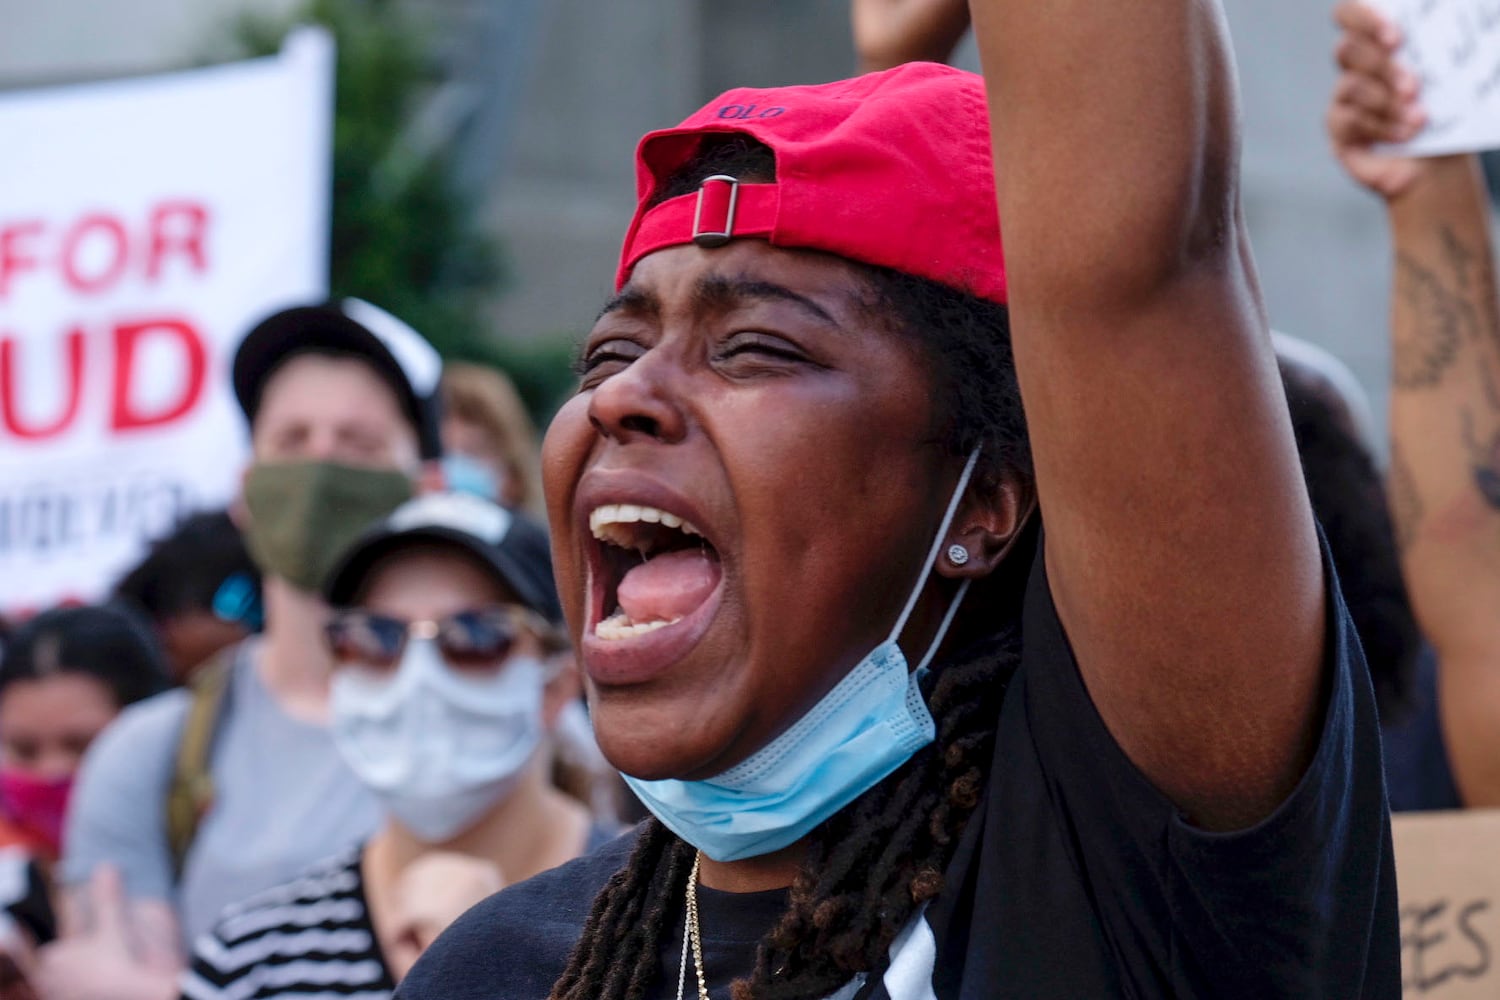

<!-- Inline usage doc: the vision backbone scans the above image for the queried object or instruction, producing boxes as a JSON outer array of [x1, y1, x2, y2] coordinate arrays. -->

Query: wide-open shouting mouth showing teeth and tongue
[[588, 504, 723, 642]]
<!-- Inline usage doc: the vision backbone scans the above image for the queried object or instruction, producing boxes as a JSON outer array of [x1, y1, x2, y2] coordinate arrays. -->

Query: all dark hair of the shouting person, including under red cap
[[551, 135, 1032, 1000]]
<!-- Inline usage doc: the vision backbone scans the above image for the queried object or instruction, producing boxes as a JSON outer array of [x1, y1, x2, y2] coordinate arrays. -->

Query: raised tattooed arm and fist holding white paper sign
[[1329, 3, 1500, 807]]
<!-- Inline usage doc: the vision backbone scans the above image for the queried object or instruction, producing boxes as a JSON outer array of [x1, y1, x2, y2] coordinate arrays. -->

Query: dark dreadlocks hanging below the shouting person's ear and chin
[[551, 624, 1020, 1000]]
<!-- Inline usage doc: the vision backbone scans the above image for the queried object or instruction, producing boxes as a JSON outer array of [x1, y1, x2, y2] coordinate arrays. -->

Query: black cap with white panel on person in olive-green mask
[[234, 298, 443, 459]]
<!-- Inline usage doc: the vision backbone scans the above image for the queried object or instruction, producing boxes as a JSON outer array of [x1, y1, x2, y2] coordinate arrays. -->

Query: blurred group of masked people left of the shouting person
[[0, 284, 639, 997]]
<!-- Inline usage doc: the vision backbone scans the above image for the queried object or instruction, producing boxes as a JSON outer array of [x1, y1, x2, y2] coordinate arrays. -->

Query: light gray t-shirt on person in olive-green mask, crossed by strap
[[62, 640, 381, 946]]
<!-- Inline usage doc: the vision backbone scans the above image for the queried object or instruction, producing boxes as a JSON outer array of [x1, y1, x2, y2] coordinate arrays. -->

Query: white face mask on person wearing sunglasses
[[332, 637, 546, 843]]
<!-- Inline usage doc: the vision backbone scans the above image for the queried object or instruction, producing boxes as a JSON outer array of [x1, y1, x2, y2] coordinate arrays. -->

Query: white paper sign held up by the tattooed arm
[[1373, 0, 1500, 156]]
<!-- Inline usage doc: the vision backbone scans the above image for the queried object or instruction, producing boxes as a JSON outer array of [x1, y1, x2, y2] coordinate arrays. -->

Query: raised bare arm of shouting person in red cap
[[971, 0, 1325, 829]]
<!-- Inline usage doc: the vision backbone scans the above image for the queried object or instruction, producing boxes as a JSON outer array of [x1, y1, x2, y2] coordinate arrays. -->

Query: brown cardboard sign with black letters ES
[[1391, 810, 1500, 1000]]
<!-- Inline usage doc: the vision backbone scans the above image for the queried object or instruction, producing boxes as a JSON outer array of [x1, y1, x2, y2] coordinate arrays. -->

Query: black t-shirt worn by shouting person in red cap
[[398, 539, 1401, 1000]]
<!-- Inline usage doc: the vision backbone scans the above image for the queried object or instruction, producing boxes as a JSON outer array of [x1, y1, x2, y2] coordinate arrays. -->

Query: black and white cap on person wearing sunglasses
[[324, 493, 563, 625]]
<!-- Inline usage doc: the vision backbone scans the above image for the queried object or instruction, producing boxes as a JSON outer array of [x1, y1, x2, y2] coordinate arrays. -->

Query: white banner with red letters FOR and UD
[[0, 28, 333, 613]]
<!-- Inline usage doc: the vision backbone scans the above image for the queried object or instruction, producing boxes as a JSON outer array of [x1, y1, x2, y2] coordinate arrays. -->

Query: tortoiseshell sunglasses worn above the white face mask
[[323, 604, 557, 672]]
